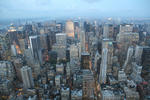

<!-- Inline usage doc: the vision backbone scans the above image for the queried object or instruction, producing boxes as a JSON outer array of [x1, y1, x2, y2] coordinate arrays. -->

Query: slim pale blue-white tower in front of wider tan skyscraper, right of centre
[[99, 48, 108, 83]]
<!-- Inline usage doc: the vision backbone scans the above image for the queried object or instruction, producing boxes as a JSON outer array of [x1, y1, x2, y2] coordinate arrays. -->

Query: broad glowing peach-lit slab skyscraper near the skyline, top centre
[[65, 20, 74, 38]]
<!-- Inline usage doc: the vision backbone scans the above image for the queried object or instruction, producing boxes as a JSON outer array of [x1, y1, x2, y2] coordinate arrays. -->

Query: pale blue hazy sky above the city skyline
[[0, 0, 150, 19]]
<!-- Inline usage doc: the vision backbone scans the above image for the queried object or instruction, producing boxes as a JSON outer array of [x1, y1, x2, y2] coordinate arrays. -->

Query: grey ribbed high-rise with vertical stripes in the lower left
[[21, 66, 34, 89]]
